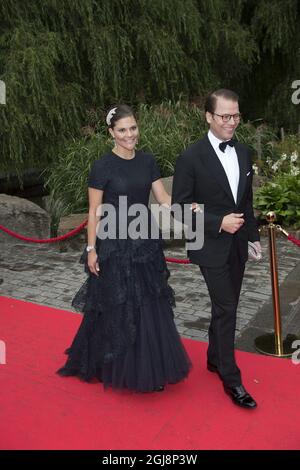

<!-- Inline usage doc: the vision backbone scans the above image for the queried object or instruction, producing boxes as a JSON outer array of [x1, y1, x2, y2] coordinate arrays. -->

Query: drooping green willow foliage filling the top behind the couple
[[0, 0, 300, 180]]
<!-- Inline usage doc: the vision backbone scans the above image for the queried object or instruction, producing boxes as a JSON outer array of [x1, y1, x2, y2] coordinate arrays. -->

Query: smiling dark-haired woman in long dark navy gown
[[57, 105, 191, 392]]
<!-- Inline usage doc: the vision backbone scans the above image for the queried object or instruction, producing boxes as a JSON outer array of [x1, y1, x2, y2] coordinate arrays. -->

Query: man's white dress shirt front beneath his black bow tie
[[208, 130, 240, 203]]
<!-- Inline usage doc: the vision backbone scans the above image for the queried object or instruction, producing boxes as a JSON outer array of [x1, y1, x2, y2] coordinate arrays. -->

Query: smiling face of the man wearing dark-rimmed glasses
[[205, 96, 239, 140]]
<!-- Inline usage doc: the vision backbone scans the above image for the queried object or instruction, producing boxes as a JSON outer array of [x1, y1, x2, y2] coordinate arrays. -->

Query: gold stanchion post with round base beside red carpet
[[255, 212, 297, 357]]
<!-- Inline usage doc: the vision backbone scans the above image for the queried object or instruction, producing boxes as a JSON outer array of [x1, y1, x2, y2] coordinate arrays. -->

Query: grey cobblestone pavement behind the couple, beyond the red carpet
[[0, 237, 300, 349]]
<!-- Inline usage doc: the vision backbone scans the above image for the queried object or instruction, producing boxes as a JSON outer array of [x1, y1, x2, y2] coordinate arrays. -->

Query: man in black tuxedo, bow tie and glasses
[[172, 89, 261, 409]]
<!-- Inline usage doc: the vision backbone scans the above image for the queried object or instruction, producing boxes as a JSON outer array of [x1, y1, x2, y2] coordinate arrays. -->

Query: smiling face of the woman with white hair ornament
[[109, 116, 139, 150]]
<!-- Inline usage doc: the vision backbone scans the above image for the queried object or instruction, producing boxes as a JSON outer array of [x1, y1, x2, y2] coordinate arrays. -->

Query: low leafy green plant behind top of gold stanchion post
[[254, 174, 300, 229]]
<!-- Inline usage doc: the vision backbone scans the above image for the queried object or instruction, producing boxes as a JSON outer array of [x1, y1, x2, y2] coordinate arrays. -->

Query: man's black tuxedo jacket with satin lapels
[[172, 135, 259, 267]]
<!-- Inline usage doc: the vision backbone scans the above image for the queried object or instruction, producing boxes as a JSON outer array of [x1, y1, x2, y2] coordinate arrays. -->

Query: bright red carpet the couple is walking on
[[0, 297, 300, 450]]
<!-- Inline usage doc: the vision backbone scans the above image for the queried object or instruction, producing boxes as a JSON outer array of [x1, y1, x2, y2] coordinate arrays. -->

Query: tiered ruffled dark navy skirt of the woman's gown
[[58, 239, 191, 392]]
